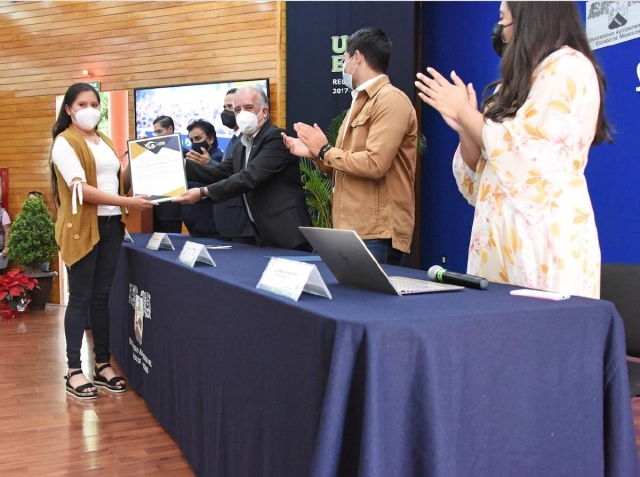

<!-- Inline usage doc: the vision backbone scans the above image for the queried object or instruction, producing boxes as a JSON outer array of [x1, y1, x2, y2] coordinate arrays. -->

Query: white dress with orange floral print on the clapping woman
[[453, 47, 600, 298]]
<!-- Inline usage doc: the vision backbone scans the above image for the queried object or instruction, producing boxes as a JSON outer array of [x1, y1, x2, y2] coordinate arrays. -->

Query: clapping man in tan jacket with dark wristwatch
[[282, 28, 418, 265]]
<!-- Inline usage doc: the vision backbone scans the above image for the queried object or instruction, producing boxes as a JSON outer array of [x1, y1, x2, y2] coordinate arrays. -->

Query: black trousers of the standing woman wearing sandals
[[64, 215, 124, 368]]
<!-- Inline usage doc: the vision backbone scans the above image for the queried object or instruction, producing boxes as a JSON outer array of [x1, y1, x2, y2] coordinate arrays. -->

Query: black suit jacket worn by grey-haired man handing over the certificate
[[185, 121, 311, 249]]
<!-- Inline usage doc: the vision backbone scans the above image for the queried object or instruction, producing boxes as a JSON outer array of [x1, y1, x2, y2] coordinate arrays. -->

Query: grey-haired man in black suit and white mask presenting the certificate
[[174, 87, 311, 251]]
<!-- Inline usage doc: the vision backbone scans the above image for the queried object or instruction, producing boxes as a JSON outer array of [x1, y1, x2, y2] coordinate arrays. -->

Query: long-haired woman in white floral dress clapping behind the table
[[416, 2, 611, 298]]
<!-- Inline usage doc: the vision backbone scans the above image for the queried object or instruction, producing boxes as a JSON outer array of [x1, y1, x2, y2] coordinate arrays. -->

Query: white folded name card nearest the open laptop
[[256, 257, 331, 301]]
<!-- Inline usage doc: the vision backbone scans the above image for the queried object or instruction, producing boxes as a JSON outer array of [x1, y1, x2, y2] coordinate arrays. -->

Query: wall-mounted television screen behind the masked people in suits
[[134, 79, 269, 150]]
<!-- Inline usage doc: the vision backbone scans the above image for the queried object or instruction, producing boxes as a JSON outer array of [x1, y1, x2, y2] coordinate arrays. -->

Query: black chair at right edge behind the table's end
[[600, 263, 640, 397]]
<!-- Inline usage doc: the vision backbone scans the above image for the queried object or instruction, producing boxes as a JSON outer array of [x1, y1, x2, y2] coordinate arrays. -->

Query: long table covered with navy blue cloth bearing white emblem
[[110, 234, 638, 477]]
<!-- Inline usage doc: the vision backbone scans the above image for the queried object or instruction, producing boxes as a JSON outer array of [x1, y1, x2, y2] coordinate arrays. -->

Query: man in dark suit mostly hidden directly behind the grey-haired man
[[213, 88, 256, 245]]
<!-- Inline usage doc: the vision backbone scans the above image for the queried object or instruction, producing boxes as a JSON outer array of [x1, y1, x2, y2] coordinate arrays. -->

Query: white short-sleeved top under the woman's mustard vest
[[51, 136, 121, 216]]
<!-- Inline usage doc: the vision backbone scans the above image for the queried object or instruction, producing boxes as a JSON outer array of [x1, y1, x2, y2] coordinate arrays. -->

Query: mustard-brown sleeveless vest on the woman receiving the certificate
[[49, 128, 126, 267]]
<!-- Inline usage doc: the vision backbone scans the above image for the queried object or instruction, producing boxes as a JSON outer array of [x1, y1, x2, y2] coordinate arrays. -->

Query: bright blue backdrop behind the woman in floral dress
[[420, 2, 640, 271]]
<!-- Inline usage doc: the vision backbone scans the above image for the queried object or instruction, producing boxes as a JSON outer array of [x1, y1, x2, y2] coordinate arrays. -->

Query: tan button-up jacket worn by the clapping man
[[319, 75, 418, 253]]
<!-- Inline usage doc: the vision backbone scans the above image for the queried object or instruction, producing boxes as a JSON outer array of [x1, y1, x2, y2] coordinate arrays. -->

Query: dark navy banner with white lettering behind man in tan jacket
[[287, 2, 418, 132]]
